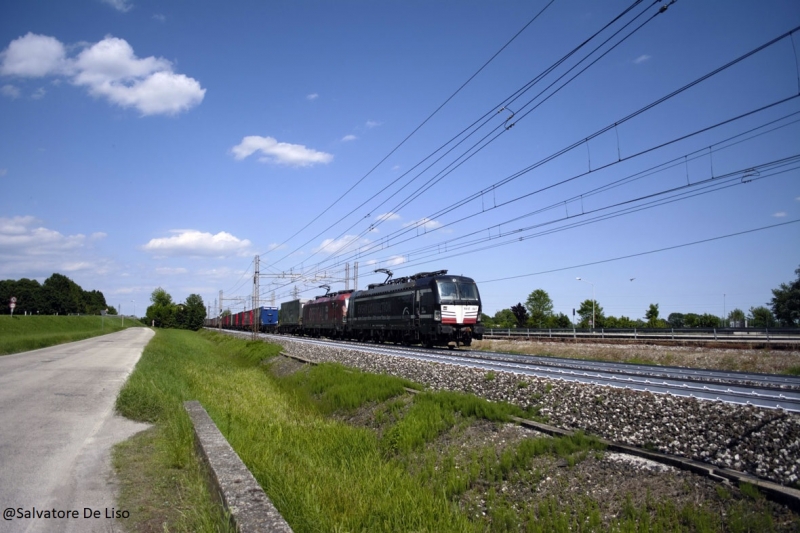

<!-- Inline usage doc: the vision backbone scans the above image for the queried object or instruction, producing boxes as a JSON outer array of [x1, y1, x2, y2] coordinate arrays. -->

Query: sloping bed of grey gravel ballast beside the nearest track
[[271, 338, 800, 487]]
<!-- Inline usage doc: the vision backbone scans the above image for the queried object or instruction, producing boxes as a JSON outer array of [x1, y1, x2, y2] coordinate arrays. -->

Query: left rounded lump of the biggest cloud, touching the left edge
[[0, 32, 65, 78]]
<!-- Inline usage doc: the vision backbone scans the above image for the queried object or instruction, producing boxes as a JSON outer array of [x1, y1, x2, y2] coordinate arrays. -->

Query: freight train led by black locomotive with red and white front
[[206, 270, 483, 348]]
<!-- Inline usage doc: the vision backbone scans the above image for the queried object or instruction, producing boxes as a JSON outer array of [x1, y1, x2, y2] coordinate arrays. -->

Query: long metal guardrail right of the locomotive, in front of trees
[[484, 328, 800, 342]]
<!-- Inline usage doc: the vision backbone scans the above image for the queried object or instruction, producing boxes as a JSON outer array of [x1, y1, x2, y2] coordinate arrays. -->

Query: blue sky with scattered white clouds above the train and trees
[[0, 0, 800, 318]]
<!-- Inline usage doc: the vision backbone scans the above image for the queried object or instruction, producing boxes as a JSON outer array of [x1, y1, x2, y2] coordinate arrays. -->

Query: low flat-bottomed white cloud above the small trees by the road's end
[[142, 230, 251, 257]]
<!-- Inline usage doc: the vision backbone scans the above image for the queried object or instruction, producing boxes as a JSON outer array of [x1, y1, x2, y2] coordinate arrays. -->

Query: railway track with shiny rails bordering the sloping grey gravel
[[262, 335, 800, 412]]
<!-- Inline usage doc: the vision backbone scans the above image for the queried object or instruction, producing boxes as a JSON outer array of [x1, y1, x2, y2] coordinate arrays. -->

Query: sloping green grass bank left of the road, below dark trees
[[0, 315, 143, 355]]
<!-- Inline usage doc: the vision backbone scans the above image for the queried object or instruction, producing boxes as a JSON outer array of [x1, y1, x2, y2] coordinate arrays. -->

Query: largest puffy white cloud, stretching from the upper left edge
[[0, 33, 206, 115]]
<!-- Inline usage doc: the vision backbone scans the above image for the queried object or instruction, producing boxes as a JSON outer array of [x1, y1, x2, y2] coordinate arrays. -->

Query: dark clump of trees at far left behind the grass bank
[[0, 274, 111, 315]]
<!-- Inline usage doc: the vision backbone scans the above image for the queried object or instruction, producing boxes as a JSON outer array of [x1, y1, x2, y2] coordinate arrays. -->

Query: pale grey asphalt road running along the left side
[[0, 328, 154, 533]]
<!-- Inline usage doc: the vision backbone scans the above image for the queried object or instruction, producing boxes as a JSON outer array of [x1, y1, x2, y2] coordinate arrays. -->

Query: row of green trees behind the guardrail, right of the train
[[481, 262, 800, 329]]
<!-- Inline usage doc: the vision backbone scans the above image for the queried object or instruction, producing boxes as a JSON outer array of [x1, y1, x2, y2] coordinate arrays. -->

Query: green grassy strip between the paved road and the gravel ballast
[[115, 330, 788, 532]]
